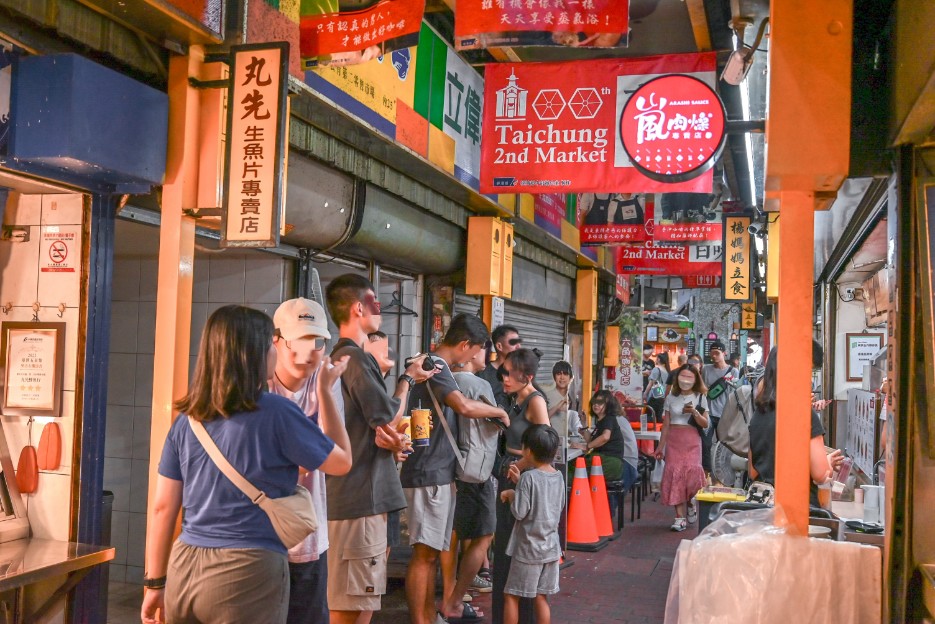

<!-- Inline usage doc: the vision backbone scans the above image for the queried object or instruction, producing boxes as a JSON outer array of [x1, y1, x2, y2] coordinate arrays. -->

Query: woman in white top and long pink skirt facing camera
[[656, 365, 708, 531]]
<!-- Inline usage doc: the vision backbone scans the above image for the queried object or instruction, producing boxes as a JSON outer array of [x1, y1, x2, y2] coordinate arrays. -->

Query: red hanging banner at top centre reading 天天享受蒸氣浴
[[455, 0, 630, 50]]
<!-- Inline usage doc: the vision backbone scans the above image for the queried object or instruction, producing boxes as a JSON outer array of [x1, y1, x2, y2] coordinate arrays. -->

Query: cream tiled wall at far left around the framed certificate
[[0, 193, 85, 540]]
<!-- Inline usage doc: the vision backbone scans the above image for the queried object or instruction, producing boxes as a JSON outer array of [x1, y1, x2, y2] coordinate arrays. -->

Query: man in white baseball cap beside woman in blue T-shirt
[[270, 298, 351, 624]]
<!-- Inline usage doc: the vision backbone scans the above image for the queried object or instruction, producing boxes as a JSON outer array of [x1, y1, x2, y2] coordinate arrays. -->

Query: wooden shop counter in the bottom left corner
[[0, 539, 115, 622]]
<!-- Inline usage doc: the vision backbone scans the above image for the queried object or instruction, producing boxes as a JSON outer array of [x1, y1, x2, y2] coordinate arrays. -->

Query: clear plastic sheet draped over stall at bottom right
[[665, 508, 883, 624]]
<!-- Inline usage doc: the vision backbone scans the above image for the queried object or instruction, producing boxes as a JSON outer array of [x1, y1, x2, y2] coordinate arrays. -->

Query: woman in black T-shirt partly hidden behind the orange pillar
[[747, 347, 844, 507]]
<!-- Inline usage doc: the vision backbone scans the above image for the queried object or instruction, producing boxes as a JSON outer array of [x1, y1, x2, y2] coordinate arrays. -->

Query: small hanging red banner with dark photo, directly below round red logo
[[653, 193, 722, 245]]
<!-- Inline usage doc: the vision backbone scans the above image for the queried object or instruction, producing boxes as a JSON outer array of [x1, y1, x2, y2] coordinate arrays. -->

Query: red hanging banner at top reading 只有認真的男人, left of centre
[[299, 0, 425, 69]]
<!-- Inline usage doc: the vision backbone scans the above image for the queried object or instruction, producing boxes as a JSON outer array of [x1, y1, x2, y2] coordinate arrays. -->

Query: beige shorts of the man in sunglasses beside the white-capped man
[[328, 514, 386, 611]]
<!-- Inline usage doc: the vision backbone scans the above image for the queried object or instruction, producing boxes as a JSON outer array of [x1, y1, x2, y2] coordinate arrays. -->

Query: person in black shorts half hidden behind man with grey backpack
[[441, 350, 510, 624]]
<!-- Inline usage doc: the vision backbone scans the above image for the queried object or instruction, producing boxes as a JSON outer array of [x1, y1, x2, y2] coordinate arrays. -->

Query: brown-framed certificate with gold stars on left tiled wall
[[0, 323, 65, 416]]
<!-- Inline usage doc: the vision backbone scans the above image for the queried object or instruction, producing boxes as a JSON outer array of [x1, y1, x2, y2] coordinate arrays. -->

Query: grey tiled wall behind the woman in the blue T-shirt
[[104, 222, 293, 583]]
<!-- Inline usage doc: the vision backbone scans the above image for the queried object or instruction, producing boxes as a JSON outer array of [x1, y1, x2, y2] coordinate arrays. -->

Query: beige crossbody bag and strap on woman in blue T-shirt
[[188, 416, 318, 548]]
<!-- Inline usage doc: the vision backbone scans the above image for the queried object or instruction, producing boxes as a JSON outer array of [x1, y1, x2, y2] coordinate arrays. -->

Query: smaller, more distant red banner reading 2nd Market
[[614, 241, 721, 276]]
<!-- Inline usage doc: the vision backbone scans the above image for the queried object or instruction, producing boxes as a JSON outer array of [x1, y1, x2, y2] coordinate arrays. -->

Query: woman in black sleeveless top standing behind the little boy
[[493, 349, 549, 624]]
